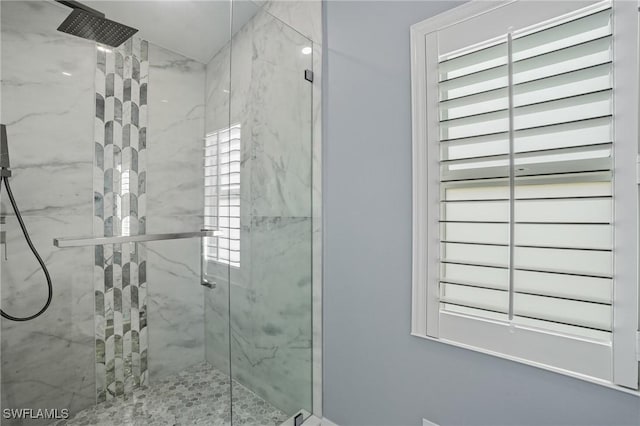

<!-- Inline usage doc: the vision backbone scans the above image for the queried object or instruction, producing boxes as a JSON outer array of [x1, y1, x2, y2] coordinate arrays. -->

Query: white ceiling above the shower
[[59, 0, 258, 64]]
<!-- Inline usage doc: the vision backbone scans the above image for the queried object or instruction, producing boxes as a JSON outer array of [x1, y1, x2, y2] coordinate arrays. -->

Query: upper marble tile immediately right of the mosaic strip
[[146, 44, 205, 217]]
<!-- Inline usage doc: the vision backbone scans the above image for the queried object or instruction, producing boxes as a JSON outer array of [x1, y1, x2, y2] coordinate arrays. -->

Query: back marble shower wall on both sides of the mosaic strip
[[0, 0, 210, 425]]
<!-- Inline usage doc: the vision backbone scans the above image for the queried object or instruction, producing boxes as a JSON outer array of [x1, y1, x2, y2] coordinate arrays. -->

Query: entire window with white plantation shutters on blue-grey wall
[[412, 1, 638, 389]]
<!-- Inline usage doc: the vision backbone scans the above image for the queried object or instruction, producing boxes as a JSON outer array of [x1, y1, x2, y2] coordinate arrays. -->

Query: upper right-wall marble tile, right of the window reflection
[[249, 53, 312, 217]]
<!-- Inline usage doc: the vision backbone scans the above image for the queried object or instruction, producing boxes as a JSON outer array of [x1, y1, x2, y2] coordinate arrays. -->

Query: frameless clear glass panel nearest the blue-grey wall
[[225, 1, 313, 425]]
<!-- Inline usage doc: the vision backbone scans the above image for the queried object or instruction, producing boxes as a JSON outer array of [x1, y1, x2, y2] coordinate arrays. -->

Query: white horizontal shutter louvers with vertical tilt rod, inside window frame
[[438, 8, 614, 342]]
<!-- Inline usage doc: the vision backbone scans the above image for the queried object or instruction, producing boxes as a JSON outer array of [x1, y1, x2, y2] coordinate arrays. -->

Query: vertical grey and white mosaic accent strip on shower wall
[[93, 37, 149, 402]]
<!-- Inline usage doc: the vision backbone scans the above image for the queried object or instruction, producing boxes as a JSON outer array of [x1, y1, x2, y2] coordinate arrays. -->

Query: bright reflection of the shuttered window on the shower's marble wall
[[203, 124, 240, 267]]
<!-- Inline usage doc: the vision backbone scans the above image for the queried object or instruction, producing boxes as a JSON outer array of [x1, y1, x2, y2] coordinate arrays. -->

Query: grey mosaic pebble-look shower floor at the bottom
[[55, 363, 289, 426]]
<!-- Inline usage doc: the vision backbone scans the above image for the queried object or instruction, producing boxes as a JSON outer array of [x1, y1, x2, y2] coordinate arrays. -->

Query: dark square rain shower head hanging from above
[[56, 0, 138, 47]]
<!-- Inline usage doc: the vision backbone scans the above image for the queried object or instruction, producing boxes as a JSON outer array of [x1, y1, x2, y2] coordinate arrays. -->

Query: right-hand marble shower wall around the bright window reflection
[[205, 1, 321, 414]]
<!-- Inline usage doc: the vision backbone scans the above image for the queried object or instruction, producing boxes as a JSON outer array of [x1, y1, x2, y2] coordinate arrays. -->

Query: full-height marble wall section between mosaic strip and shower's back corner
[[146, 43, 205, 381]]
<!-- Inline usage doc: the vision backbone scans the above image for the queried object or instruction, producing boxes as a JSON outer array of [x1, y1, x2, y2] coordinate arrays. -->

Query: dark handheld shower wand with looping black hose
[[0, 124, 53, 321]]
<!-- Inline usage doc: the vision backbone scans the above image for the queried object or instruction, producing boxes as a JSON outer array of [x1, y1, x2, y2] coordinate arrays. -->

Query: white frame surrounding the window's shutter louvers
[[411, 0, 640, 396]]
